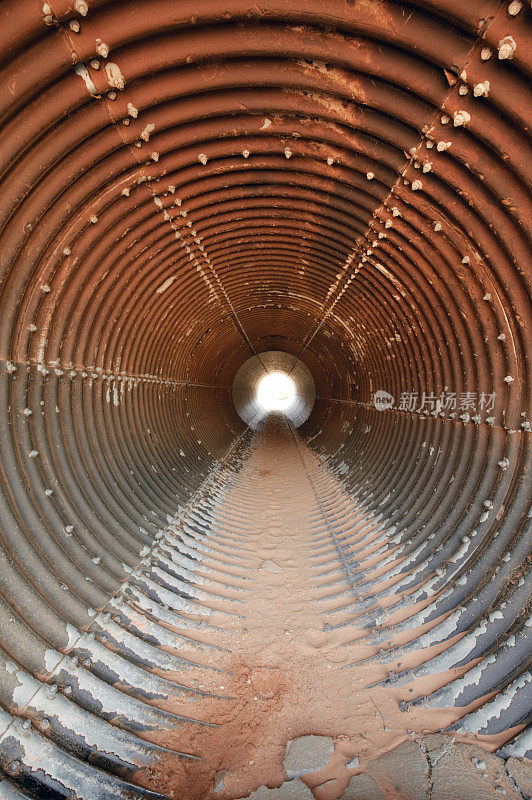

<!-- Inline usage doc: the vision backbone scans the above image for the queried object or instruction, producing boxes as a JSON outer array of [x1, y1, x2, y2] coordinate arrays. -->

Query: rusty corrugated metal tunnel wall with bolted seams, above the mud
[[0, 0, 532, 800]]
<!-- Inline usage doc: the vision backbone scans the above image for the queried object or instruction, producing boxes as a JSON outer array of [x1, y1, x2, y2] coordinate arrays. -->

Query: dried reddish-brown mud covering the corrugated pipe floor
[[132, 418, 519, 800]]
